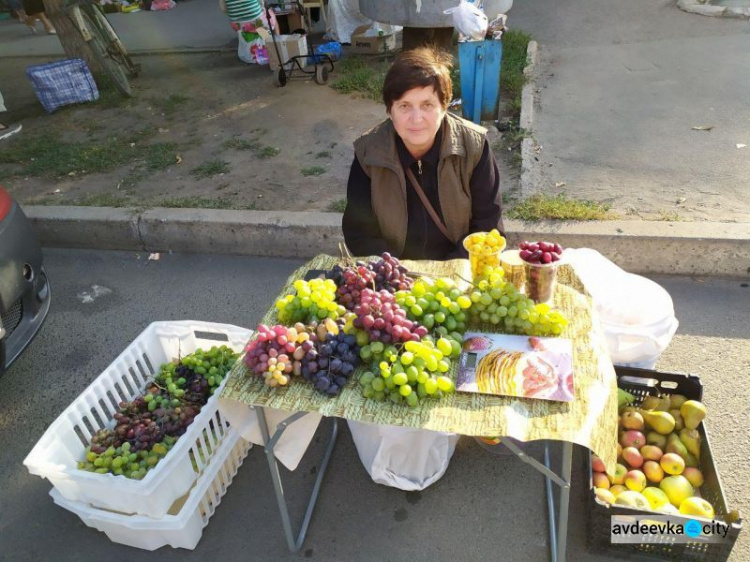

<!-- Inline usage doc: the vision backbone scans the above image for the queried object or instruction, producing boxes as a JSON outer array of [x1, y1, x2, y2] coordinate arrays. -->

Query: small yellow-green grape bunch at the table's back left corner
[[276, 279, 346, 326]]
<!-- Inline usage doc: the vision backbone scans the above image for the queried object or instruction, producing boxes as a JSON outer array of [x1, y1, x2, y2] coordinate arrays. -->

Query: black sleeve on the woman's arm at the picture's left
[[341, 156, 392, 256]]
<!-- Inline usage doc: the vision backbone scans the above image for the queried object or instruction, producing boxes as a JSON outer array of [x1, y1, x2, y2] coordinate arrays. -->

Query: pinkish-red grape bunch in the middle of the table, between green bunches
[[354, 289, 428, 343]]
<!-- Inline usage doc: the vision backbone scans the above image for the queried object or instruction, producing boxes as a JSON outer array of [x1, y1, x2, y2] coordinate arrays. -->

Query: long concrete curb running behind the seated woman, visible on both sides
[[25, 207, 750, 278]]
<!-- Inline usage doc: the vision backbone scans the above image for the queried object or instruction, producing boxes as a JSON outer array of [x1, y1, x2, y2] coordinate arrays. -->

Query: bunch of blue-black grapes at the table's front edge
[[301, 331, 359, 396]]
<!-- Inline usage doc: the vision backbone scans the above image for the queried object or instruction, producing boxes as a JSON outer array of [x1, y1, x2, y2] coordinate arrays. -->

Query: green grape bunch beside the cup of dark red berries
[[469, 268, 568, 336]]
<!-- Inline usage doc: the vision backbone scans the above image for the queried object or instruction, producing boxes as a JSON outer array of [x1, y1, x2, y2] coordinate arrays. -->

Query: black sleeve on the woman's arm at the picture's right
[[448, 139, 505, 259]]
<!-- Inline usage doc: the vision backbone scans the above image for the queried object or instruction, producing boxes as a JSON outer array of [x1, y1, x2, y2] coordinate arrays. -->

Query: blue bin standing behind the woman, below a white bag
[[458, 39, 503, 123]]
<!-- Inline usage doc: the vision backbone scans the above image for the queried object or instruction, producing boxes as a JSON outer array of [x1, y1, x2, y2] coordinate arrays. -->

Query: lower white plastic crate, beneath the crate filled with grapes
[[50, 429, 252, 550]]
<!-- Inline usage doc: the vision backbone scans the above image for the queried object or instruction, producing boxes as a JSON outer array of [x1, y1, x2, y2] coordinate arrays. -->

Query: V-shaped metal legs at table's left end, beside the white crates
[[253, 407, 339, 552]]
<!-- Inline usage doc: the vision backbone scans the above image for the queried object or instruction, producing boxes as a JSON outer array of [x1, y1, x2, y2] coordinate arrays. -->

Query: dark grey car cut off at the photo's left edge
[[0, 186, 51, 373]]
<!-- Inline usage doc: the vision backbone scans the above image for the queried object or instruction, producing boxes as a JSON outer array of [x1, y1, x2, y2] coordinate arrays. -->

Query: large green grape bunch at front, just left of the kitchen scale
[[359, 338, 460, 407]]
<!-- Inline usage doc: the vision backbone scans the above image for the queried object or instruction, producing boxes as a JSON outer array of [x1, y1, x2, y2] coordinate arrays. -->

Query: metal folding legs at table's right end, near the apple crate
[[501, 438, 573, 562]]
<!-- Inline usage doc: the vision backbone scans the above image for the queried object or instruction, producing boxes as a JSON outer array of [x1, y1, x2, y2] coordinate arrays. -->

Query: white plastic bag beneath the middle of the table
[[347, 420, 459, 491]]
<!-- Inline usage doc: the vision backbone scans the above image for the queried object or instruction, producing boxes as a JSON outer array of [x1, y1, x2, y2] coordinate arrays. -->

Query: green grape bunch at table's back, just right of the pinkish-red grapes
[[396, 277, 471, 333]]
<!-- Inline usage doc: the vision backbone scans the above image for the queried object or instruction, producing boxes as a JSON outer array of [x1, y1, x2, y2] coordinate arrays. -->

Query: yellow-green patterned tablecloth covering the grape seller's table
[[221, 255, 617, 469]]
